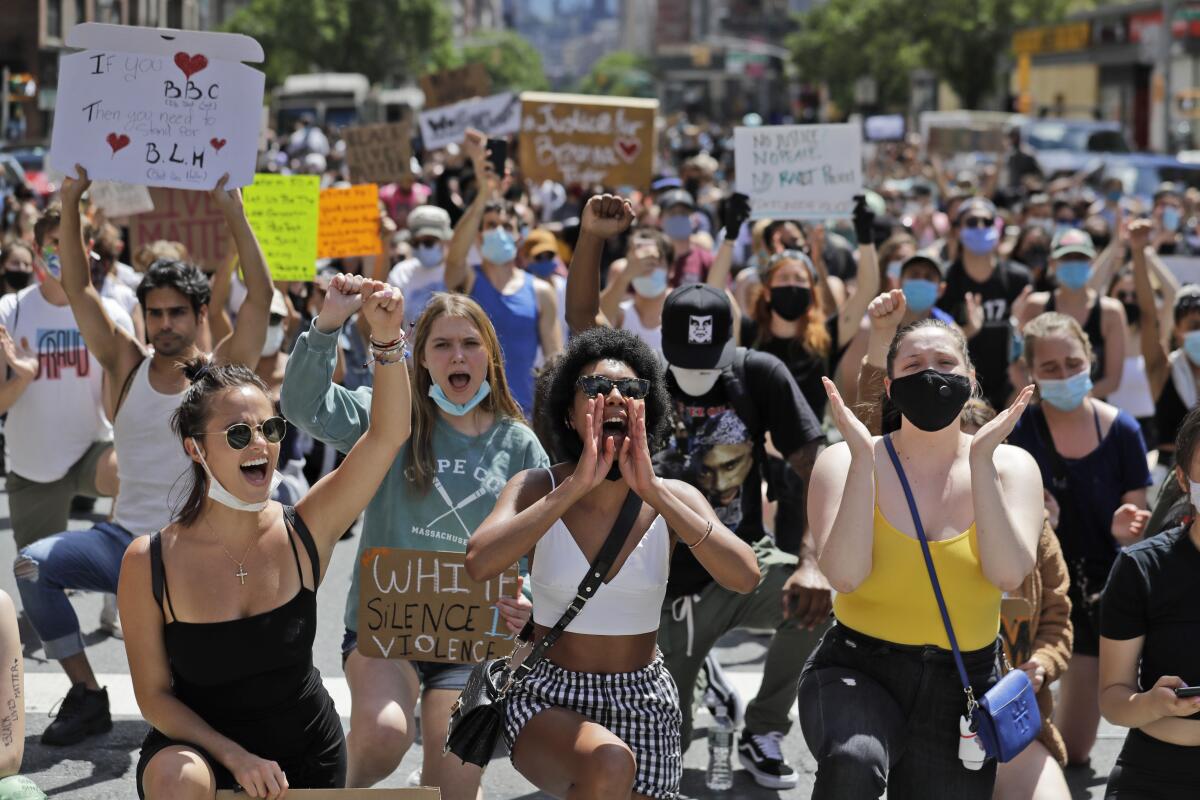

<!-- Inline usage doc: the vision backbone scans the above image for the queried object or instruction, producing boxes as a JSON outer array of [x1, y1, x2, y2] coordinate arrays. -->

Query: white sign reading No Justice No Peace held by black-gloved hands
[[733, 124, 863, 219]]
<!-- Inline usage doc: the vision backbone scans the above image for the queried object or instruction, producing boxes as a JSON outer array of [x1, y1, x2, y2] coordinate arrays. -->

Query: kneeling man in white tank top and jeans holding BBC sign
[[13, 167, 272, 745]]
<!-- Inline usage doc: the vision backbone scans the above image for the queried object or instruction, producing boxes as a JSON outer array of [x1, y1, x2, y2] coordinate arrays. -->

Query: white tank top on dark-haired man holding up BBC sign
[[113, 357, 192, 536]]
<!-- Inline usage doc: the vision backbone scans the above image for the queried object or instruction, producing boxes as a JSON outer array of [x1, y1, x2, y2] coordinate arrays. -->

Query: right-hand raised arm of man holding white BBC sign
[[211, 175, 275, 367]]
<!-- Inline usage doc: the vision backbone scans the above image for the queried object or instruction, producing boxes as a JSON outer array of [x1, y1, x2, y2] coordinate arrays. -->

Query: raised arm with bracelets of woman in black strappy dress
[[296, 281, 413, 564]]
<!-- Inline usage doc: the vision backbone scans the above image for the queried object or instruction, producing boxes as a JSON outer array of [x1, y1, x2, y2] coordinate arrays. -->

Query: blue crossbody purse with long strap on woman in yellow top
[[883, 435, 1042, 762]]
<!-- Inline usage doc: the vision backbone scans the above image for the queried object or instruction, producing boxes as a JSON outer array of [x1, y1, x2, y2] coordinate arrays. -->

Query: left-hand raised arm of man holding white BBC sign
[[59, 164, 144, 386]]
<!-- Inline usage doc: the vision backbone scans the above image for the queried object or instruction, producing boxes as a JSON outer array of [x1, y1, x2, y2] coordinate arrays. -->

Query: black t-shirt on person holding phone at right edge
[[1100, 527, 1200, 720]]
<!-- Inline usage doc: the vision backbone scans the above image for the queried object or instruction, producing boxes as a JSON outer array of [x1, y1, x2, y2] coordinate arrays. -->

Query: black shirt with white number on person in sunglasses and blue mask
[[937, 260, 1030, 410]]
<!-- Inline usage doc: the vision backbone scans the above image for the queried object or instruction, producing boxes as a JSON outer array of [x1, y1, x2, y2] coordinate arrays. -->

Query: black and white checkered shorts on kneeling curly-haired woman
[[504, 654, 683, 800]]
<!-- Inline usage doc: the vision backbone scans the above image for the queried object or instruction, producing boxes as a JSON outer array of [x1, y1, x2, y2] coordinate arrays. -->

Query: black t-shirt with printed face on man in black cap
[[654, 350, 822, 597]]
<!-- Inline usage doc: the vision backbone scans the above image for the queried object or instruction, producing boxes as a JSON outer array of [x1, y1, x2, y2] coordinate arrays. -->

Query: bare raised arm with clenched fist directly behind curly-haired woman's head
[[566, 194, 634, 333]]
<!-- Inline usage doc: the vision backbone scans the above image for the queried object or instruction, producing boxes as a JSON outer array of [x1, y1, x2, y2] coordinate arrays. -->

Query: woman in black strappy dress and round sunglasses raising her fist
[[119, 276, 410, 800]]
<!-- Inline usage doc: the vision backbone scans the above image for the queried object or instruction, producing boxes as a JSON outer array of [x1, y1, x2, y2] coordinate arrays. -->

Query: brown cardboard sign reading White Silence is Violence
[[359, 547, 517, 663]]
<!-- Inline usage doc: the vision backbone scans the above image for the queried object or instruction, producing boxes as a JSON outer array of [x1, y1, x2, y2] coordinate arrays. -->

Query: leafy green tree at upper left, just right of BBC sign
[[226, 0, 452, 85]]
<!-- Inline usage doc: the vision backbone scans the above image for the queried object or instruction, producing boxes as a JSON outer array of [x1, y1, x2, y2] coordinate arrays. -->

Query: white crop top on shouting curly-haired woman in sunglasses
[[529, 470, 671, 636]]
